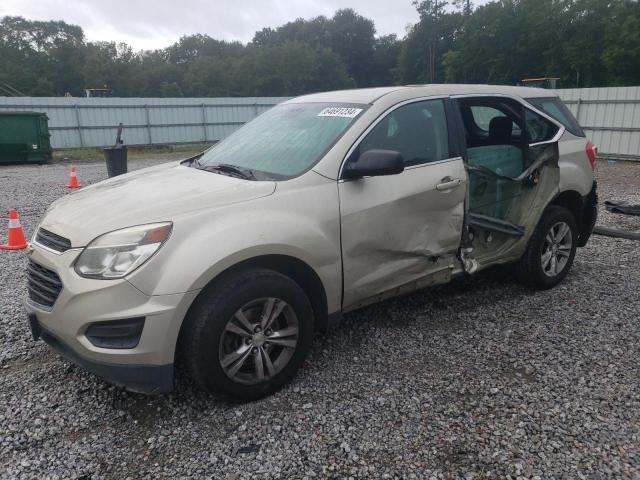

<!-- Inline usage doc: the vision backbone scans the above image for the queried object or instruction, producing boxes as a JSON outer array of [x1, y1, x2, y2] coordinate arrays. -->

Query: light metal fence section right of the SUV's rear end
[[556, 87, 640, 160]]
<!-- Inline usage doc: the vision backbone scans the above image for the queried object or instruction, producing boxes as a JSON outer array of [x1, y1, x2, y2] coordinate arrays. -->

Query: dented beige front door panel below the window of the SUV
[[338, 158, 467, 309]]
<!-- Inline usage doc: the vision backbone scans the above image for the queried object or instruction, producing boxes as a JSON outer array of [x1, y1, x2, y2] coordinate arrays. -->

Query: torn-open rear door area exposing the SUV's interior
[[458, 97, 558, 266]]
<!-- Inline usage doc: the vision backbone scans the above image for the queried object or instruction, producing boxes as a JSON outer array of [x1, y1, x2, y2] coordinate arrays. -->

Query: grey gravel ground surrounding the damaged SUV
[[0, 161, 640, 479]]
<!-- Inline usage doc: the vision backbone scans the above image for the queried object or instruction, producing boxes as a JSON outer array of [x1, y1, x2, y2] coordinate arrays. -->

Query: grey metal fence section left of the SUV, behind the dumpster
[[0, 97, 286, 148]]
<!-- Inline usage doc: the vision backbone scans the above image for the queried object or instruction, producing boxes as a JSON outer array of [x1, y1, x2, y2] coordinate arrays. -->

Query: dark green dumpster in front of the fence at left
[[0, 111, 52, 164]]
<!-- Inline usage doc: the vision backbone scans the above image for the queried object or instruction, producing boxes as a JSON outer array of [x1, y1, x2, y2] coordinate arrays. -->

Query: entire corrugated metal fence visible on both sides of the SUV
[[0, 87, 640, 160]]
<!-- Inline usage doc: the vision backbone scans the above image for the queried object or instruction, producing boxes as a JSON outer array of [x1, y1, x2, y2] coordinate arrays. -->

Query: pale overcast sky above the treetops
[[0, 0, 484, 50]]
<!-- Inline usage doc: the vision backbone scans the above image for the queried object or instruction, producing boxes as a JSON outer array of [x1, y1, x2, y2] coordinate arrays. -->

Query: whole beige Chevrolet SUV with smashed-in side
[[26, 85, 596, 399]]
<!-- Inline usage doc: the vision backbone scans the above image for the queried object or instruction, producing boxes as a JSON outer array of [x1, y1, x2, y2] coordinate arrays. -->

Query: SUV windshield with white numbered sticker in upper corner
[[194, 103, 366, 180]]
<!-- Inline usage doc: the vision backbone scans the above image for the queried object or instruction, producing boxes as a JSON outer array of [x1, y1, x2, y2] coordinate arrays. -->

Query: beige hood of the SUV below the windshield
[[40, 162, 276, 248]]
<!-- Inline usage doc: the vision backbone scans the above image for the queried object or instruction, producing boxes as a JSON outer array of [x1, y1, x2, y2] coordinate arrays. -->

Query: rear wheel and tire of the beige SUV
[[516, 205, 579, 290]]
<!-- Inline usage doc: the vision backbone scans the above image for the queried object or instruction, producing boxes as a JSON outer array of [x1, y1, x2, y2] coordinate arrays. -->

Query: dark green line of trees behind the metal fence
[[0, 0, 640, 97]]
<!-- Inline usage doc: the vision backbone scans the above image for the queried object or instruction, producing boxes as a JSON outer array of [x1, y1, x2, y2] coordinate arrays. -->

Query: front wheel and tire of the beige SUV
[[181, 270, 314, 401]]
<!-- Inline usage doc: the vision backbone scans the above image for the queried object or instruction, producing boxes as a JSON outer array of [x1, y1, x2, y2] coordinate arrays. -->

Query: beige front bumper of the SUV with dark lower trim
[[25, 244, 198, 393]]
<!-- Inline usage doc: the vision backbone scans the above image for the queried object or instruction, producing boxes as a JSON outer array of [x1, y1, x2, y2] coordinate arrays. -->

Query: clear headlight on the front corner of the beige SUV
[[75, 222, 173, 280]]
